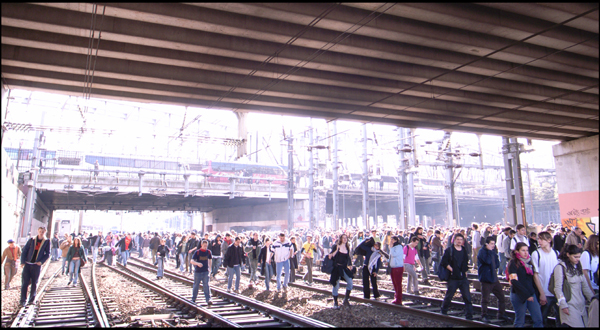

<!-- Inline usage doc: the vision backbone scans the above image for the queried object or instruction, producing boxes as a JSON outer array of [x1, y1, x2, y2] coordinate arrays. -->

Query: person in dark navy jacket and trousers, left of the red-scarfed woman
[[477, 236, 510, 323]]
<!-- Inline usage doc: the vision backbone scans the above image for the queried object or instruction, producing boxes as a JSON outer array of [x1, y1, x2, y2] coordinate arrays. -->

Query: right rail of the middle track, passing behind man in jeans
[[130, 257, 333, 328]]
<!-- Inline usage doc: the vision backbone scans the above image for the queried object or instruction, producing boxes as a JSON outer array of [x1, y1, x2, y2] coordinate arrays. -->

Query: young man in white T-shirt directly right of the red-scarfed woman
[[531, 231, 560, 327]]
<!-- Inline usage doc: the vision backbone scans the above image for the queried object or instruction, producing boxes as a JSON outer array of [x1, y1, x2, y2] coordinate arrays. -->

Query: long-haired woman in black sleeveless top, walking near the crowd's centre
[[327, 234, 353, 309]]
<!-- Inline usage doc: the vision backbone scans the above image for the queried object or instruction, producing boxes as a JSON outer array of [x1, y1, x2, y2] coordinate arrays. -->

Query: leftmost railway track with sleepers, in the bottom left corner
[[11, 263, 109, 328]]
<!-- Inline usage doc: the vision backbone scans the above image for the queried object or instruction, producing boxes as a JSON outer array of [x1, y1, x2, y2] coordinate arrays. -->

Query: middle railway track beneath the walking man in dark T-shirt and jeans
[[121, 258, 333, 328]]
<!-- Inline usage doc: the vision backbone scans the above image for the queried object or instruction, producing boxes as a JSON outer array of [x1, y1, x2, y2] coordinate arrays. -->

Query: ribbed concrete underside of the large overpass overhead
[[2, 2, 598, 140]]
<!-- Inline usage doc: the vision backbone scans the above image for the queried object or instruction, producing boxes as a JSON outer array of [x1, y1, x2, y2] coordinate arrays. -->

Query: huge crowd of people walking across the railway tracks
[[2, 223, 599, 327]]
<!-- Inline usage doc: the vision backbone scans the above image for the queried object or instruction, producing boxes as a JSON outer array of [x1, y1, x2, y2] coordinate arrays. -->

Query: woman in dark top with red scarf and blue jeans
[[507, 242, 546, 328]]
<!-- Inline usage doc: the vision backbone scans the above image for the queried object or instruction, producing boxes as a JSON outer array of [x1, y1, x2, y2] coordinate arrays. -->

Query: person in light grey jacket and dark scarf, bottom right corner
[[550, 244, 598, 328]]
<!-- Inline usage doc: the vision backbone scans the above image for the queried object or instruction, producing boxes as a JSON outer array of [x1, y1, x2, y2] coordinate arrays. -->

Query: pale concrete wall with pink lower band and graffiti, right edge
[[552, 135, 599, 235]]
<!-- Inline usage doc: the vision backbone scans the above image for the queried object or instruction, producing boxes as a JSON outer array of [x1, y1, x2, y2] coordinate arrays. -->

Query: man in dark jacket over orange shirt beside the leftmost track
[[20, 226, 50, 306]]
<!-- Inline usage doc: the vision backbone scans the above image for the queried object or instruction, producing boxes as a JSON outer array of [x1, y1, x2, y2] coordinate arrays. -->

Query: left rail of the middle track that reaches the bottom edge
[[104, 264, 241, 328]]
